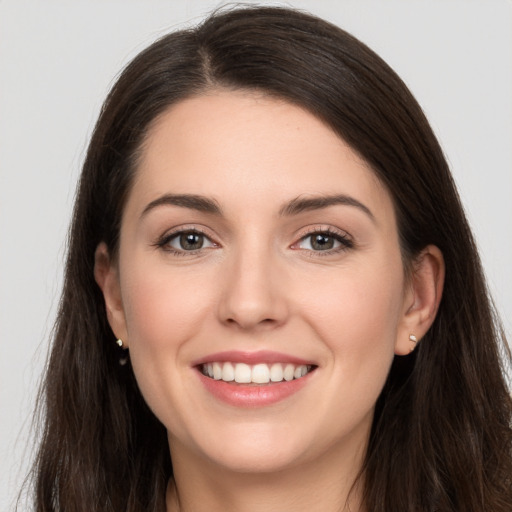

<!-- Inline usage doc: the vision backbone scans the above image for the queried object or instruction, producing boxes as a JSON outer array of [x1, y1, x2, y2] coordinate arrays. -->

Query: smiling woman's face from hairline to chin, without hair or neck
[[104, 92, 416, 471]]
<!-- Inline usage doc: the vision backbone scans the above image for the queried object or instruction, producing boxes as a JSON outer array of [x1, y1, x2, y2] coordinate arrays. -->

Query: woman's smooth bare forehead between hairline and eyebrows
[[128, 91, 392, 220]]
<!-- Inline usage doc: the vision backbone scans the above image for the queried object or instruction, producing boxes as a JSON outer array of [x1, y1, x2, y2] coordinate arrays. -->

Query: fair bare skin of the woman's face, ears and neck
[[95, 91, 444, 512]]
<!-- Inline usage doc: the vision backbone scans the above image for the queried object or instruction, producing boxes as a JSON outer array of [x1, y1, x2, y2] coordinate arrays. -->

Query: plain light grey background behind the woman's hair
[[0, 0, 512, 512]]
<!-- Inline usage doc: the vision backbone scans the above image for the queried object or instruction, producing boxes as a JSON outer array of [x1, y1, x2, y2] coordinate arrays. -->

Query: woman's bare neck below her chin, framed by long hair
[[167, 434, 365, 512]]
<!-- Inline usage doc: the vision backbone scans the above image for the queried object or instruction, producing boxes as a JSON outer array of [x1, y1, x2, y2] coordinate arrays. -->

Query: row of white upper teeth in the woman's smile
[[202, 362, 312, 384]]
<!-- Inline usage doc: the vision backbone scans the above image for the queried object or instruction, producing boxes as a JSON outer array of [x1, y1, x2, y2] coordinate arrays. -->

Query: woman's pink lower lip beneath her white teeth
[[197, 371, 313, 407]]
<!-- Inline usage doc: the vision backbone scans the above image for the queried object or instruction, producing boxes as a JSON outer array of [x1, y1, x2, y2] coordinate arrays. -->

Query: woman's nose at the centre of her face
[[219, 241, 289, 330]]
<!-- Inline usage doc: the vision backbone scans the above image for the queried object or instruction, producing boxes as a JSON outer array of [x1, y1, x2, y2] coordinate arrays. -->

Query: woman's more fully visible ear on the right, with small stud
[[395, 245, 445, 355]]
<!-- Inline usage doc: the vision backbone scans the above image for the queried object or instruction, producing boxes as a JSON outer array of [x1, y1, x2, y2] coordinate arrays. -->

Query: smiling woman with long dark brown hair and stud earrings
[[30, 7, 512, 512]]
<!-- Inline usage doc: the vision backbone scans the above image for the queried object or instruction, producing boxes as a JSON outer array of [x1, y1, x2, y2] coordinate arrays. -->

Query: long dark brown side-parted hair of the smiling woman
[[29, 7, 512, 512]]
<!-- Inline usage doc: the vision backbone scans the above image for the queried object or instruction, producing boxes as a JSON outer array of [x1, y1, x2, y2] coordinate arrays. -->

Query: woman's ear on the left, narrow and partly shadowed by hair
[[94, 242, 128, 348]]
